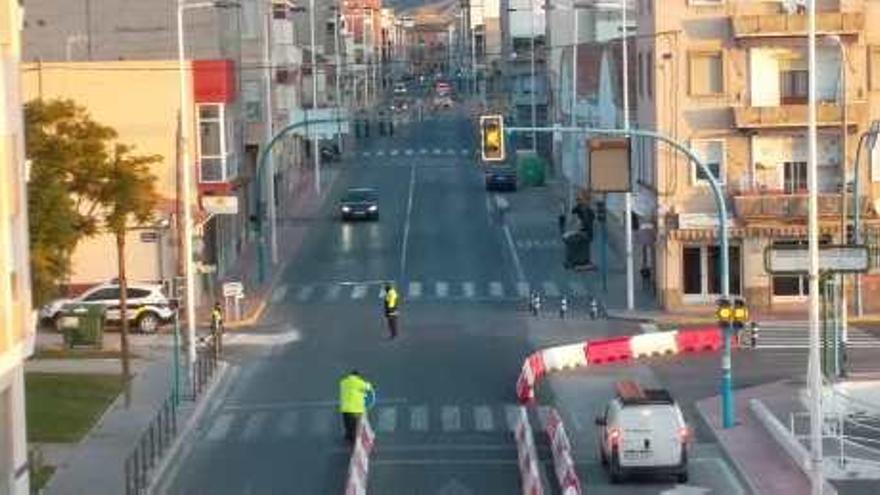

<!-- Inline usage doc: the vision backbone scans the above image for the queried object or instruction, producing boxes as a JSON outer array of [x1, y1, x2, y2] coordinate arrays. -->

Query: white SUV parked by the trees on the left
[[40, 282, 174, 333]]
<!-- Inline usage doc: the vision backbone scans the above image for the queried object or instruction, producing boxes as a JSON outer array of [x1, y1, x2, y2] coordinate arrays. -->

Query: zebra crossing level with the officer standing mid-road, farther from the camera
[[283, 280, 591, 303]]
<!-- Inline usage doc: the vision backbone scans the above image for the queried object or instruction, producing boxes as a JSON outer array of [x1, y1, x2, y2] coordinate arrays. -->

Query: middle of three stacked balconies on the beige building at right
[[733, 102, 867, 129]]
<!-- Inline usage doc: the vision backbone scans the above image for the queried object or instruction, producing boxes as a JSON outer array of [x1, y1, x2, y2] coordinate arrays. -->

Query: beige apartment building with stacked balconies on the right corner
[[633, 0, 880, 309]]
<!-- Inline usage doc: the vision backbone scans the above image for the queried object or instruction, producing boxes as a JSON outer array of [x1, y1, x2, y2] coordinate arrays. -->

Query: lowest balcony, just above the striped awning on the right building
[[733, 192, 876, 223]]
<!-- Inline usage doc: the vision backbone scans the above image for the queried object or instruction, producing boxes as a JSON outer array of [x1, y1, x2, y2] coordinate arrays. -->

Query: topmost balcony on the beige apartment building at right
[[731, 12, 865, 38]]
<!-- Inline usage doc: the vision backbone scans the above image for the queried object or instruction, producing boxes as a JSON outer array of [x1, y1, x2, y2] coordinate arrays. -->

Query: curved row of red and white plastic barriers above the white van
[[516, 326, 724, 404]]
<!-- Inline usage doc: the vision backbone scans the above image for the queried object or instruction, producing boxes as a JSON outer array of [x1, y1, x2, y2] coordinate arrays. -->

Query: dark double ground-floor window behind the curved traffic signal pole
[[681, 245, 742, 299]]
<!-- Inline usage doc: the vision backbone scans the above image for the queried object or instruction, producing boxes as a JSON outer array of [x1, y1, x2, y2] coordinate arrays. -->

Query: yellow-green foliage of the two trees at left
[[24, 100, 160, 305]]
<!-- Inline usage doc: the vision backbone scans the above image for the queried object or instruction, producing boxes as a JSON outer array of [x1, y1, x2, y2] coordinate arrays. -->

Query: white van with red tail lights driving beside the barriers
[[596, 381, 691, 483]]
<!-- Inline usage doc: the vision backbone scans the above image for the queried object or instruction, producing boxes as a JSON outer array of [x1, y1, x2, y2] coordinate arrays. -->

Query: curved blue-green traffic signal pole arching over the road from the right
[[505, 126, 734, 428]]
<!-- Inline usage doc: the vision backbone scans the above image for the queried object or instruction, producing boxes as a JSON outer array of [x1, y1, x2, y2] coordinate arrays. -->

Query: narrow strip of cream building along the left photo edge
[[0, 0, 36, 495]]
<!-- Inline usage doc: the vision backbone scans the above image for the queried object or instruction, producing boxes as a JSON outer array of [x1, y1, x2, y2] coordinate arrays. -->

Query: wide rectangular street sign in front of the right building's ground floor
[[764, 245, 871, 275]]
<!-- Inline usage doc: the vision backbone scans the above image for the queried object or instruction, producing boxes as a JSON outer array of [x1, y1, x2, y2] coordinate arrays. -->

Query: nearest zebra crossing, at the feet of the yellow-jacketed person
[[201, 404, 583, 443]]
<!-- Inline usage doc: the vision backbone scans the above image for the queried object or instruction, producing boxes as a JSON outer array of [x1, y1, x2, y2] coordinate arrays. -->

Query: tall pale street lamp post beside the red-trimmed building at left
[[177, 0, 239, 373]]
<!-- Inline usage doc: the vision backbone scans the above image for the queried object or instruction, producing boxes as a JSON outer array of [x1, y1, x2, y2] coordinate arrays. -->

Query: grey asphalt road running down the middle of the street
[[158, 102, 737, 495]]
